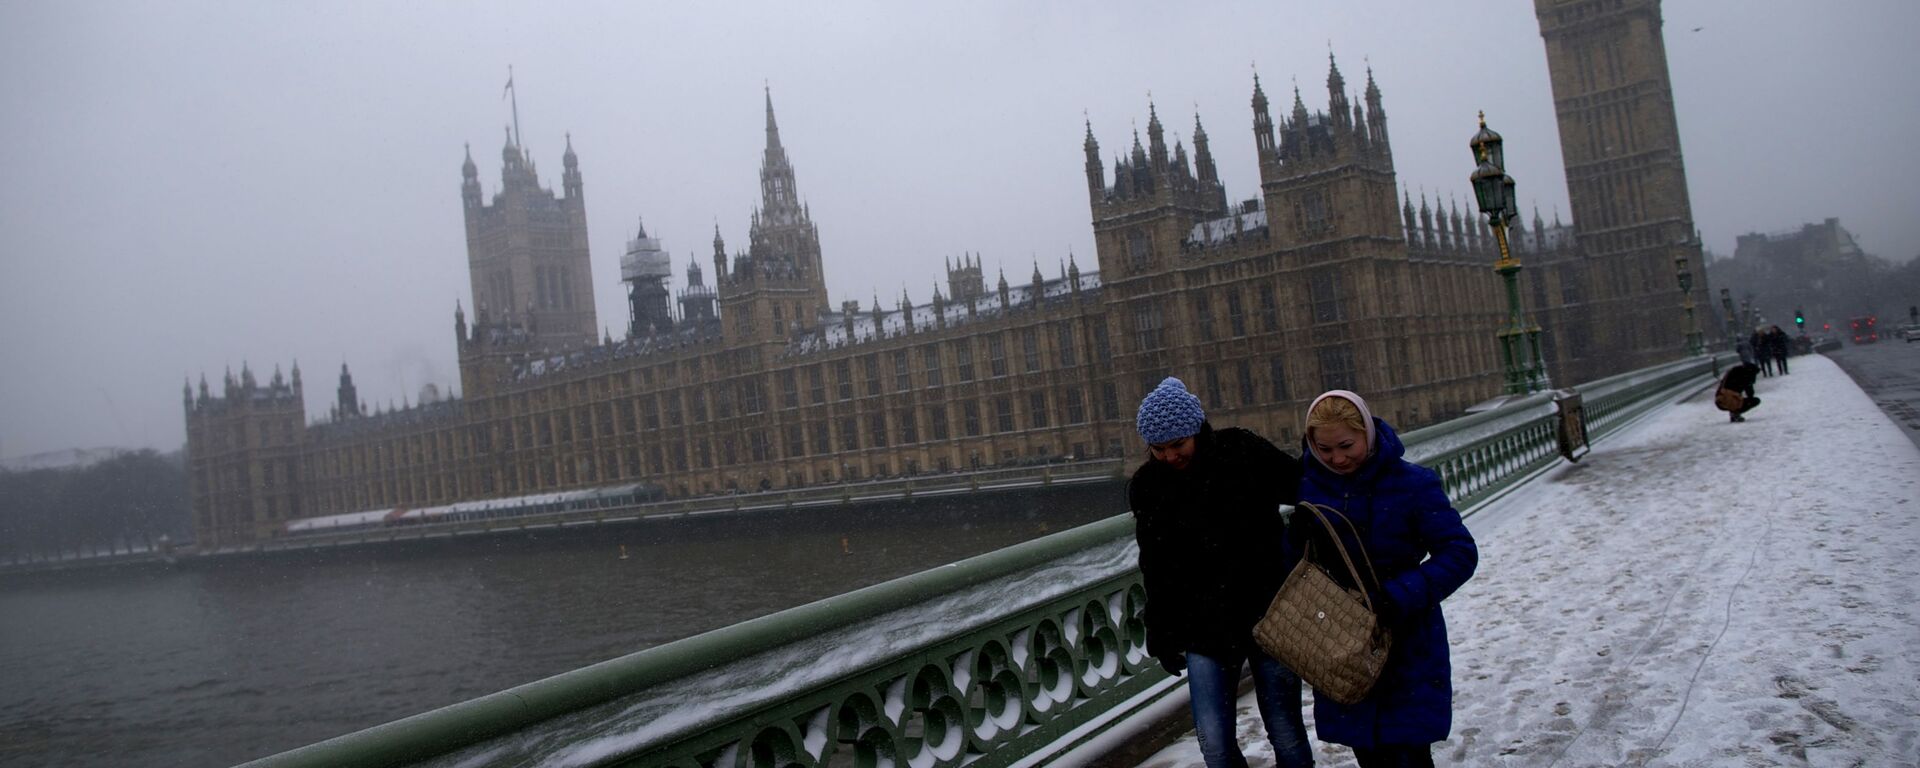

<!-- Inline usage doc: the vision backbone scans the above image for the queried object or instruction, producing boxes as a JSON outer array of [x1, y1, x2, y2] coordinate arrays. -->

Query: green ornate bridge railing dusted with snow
[[248, 357, 1713, 768]]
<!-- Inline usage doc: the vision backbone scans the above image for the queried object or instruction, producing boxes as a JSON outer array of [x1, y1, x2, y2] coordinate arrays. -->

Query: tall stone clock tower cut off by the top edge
[[1509, 0, 1718, 382]]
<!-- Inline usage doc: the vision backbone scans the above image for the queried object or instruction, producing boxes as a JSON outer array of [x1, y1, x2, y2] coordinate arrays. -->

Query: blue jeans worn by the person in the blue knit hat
[[1187, 651, 1313, 768]]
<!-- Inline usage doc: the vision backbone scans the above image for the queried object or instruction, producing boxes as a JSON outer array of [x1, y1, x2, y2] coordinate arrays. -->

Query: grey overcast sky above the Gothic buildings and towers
[[0, 0, 1920, 457]]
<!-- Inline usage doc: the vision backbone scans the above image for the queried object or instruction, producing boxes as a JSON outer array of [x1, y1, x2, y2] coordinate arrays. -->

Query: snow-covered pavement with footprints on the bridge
[[1144, 357, 1920, 768]]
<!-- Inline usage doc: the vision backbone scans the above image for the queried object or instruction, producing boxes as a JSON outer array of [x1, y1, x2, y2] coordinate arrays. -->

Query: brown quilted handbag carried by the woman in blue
[[1254, 501, 1394, 705]]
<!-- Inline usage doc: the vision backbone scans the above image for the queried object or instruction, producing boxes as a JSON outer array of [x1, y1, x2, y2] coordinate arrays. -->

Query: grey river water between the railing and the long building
[[0, 484, 1125, 766]]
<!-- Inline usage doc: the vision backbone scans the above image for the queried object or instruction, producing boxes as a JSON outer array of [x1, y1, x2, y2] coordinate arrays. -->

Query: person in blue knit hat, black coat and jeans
[[1127, 376, 1313, 768]]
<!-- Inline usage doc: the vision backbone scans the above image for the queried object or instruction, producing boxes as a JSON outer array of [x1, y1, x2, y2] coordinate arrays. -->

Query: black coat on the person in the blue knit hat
[[1127, 424, 1300, 668]]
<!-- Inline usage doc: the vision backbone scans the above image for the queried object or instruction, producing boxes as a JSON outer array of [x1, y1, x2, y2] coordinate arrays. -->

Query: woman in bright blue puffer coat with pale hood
[[1288, 390, 1480, 768]]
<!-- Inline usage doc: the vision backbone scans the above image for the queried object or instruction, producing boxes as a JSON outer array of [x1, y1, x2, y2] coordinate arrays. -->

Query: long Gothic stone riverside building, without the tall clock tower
[[188, 25, 1684, 543]]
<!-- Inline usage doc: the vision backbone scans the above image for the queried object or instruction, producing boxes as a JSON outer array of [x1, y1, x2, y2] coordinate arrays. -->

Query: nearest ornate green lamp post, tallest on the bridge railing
[[1467, 111, 1548, 394]]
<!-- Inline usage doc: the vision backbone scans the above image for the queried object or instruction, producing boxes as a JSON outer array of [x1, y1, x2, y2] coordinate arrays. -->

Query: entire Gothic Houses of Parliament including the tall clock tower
[[182, 0, 1716, 549]]
